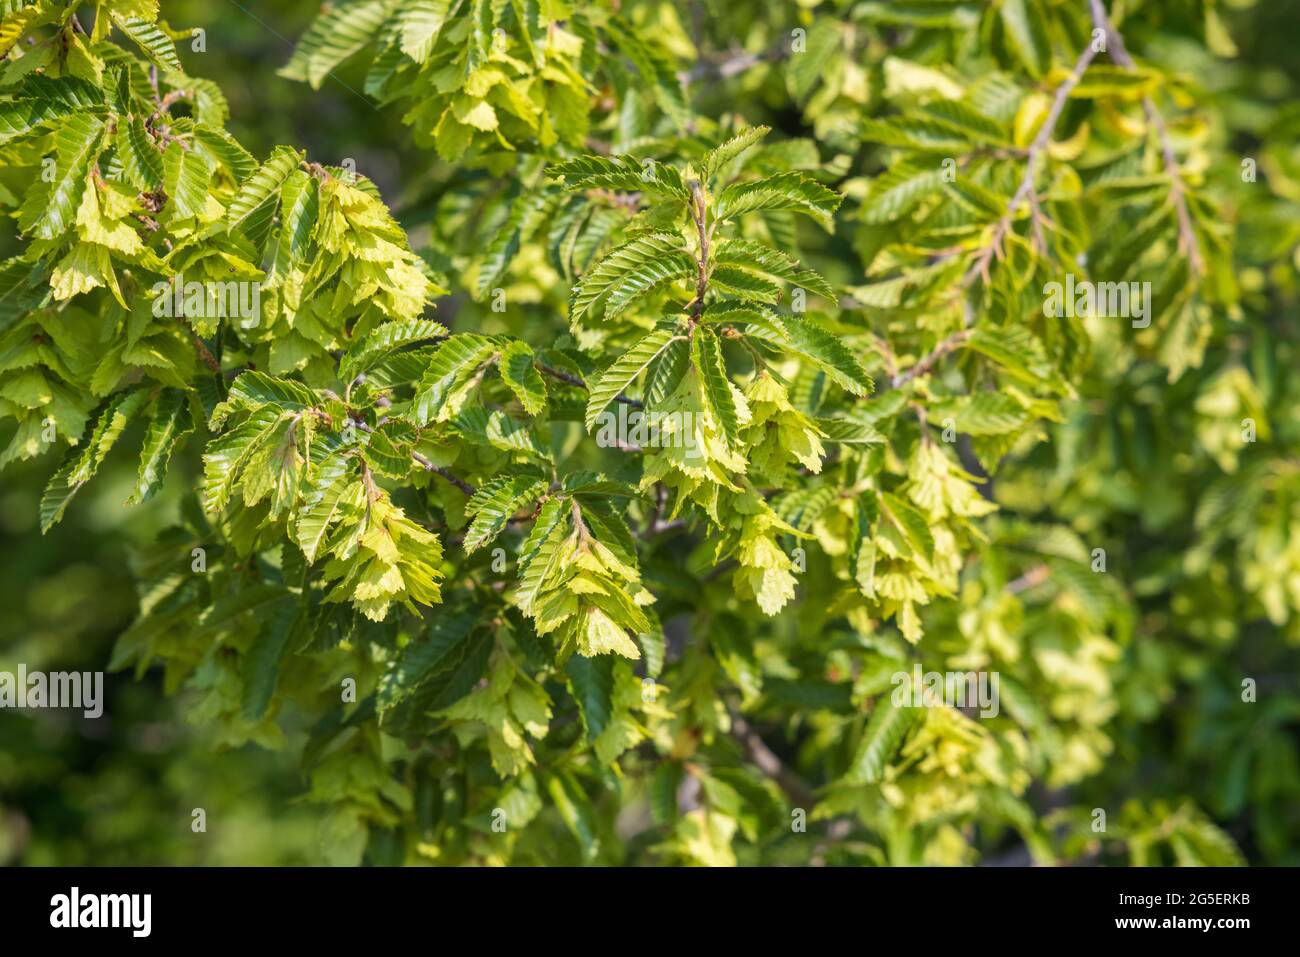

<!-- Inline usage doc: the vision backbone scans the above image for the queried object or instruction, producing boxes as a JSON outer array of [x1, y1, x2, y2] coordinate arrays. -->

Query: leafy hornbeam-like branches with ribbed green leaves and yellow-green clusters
[[0, 0, 1300, 865]]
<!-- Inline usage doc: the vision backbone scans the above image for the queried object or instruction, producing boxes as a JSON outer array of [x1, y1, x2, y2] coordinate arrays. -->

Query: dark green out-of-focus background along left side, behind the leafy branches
[[0, 0, 397, 865]]
